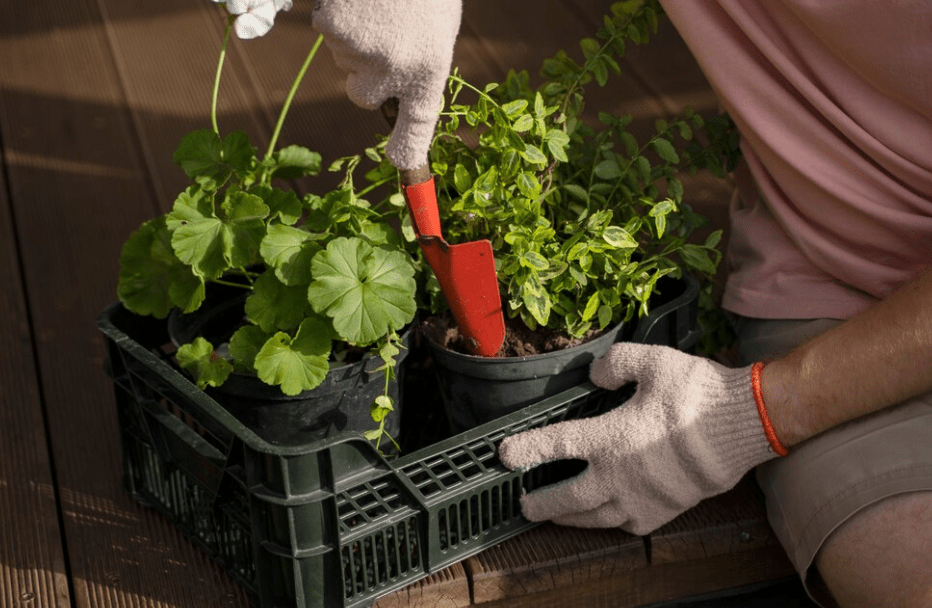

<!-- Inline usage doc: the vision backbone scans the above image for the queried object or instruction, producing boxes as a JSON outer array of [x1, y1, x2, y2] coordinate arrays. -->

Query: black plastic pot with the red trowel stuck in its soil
[[427, 277, 699, 433]]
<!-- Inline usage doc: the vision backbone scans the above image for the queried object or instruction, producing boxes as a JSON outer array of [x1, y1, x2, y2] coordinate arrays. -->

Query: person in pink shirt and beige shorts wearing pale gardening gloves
[[242, 0, 932, 608]]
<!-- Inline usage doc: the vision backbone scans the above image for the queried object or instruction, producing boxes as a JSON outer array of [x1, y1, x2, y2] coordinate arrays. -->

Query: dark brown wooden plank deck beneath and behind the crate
[[0, 0, 790, 608]]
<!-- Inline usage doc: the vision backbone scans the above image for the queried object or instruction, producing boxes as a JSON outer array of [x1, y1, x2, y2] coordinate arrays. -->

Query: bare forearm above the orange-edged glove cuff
[[761, 269, 932, 447]]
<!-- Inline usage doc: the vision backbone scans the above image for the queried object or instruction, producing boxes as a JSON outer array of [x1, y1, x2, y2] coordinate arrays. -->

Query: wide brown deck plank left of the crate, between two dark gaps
[[0, 0, 246, 607]]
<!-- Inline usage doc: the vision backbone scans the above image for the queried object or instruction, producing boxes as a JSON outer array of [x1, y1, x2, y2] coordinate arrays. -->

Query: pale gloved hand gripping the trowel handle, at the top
[[314, 0, 462, 170]]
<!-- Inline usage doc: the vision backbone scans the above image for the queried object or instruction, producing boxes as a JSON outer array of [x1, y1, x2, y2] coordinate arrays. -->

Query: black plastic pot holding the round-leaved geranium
[[168, 284, 411, 451]]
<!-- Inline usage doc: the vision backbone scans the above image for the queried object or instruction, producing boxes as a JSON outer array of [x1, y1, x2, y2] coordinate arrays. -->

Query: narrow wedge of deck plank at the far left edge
[[0, 133, 71, 607]]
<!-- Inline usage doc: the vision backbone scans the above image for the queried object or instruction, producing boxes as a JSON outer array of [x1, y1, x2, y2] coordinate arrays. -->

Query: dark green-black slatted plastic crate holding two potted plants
[[98, 274, 698, 608]]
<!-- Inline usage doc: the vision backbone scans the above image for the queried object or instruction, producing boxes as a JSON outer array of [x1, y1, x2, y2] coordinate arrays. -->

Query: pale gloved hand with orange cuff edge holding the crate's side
[[499, 343, 782, 534]]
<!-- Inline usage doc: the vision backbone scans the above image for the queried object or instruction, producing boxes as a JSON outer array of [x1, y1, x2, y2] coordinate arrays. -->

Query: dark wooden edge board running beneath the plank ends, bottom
[[477, 549, 786, 608]]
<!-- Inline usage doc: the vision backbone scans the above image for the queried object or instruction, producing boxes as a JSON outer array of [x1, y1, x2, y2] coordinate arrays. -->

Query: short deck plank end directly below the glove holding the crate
[[465, 524, 648, 604]]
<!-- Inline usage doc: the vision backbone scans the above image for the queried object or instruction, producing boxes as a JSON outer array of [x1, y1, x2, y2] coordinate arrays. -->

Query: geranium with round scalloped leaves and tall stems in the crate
[[118, 17, 416, 441]]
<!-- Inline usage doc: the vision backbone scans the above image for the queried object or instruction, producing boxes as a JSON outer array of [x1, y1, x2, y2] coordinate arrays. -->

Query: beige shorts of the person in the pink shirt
[[736, 318, 932, 606]]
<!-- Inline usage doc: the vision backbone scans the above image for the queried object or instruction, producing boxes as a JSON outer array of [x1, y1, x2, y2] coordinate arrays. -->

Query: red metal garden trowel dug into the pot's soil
[[382, 99, 505, 357]]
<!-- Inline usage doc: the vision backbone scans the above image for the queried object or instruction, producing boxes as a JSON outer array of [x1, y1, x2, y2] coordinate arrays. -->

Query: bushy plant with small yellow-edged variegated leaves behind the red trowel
[[368, 0, 737, 337]]
